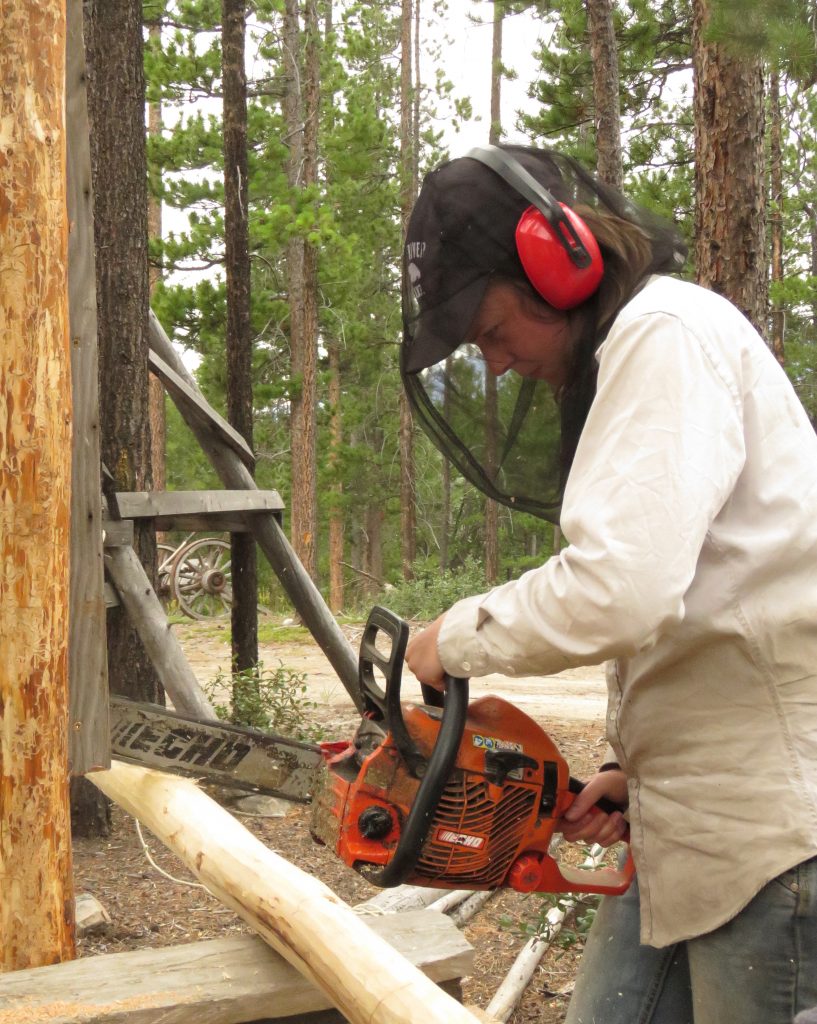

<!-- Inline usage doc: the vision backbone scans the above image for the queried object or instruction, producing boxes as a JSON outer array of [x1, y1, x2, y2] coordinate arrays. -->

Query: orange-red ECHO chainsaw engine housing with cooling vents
[[312, 696, 633, 893]]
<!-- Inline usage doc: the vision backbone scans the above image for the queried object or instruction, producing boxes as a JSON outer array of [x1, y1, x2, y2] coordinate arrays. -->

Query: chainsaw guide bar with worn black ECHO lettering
[[111, 696, 324, 801]]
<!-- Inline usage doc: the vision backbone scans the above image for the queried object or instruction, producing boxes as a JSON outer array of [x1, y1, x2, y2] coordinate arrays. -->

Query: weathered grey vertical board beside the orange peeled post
[[66, 0, 111, 775]]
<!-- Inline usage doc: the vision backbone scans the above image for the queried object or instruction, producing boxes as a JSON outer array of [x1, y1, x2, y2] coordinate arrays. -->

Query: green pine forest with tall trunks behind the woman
[[124, 0, 817, 634]]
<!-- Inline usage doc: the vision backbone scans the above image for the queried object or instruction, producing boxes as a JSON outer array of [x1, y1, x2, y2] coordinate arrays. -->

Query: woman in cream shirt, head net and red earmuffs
[[402, 147, 817, 1024]]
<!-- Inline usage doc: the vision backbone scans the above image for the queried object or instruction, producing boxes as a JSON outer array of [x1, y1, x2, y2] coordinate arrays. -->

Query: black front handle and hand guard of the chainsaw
[[358, 606, 468, 888]]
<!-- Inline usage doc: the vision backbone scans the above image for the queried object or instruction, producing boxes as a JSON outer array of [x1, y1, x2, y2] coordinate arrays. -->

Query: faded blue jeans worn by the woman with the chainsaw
[[565, 857, 817, 1024]]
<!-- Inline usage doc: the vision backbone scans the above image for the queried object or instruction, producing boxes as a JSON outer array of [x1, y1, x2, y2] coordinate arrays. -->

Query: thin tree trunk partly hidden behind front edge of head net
[[399, 0, 417, 580]]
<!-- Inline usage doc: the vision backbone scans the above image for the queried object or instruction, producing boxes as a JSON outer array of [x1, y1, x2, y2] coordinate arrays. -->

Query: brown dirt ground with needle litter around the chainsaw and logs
[[74, 622, 605, 1024]]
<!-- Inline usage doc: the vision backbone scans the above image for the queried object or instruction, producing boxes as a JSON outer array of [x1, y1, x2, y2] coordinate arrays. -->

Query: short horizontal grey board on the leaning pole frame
[[117, 490, 284, 534]]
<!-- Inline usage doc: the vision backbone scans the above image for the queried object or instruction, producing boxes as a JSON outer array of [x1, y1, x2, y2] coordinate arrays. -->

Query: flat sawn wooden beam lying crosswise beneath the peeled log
[[0, 910, 474, 1024]]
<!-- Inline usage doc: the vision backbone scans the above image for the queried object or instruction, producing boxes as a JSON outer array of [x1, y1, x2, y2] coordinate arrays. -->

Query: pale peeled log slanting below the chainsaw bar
[[89, 762, 495, 1024]]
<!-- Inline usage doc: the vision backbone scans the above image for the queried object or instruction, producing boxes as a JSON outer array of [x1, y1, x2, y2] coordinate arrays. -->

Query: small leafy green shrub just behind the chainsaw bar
[[204, 662, 323, 740]]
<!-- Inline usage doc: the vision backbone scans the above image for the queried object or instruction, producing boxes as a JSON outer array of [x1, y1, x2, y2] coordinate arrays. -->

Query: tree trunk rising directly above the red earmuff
[[585, 0, 624, 188]]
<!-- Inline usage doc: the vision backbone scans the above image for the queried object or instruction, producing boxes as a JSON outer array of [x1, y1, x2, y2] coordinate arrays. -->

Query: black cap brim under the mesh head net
[[402, 274, 490, 374]]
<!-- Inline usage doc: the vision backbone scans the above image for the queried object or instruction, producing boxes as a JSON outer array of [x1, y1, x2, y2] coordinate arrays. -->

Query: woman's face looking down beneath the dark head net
[[467, 282, 572, 390]]
